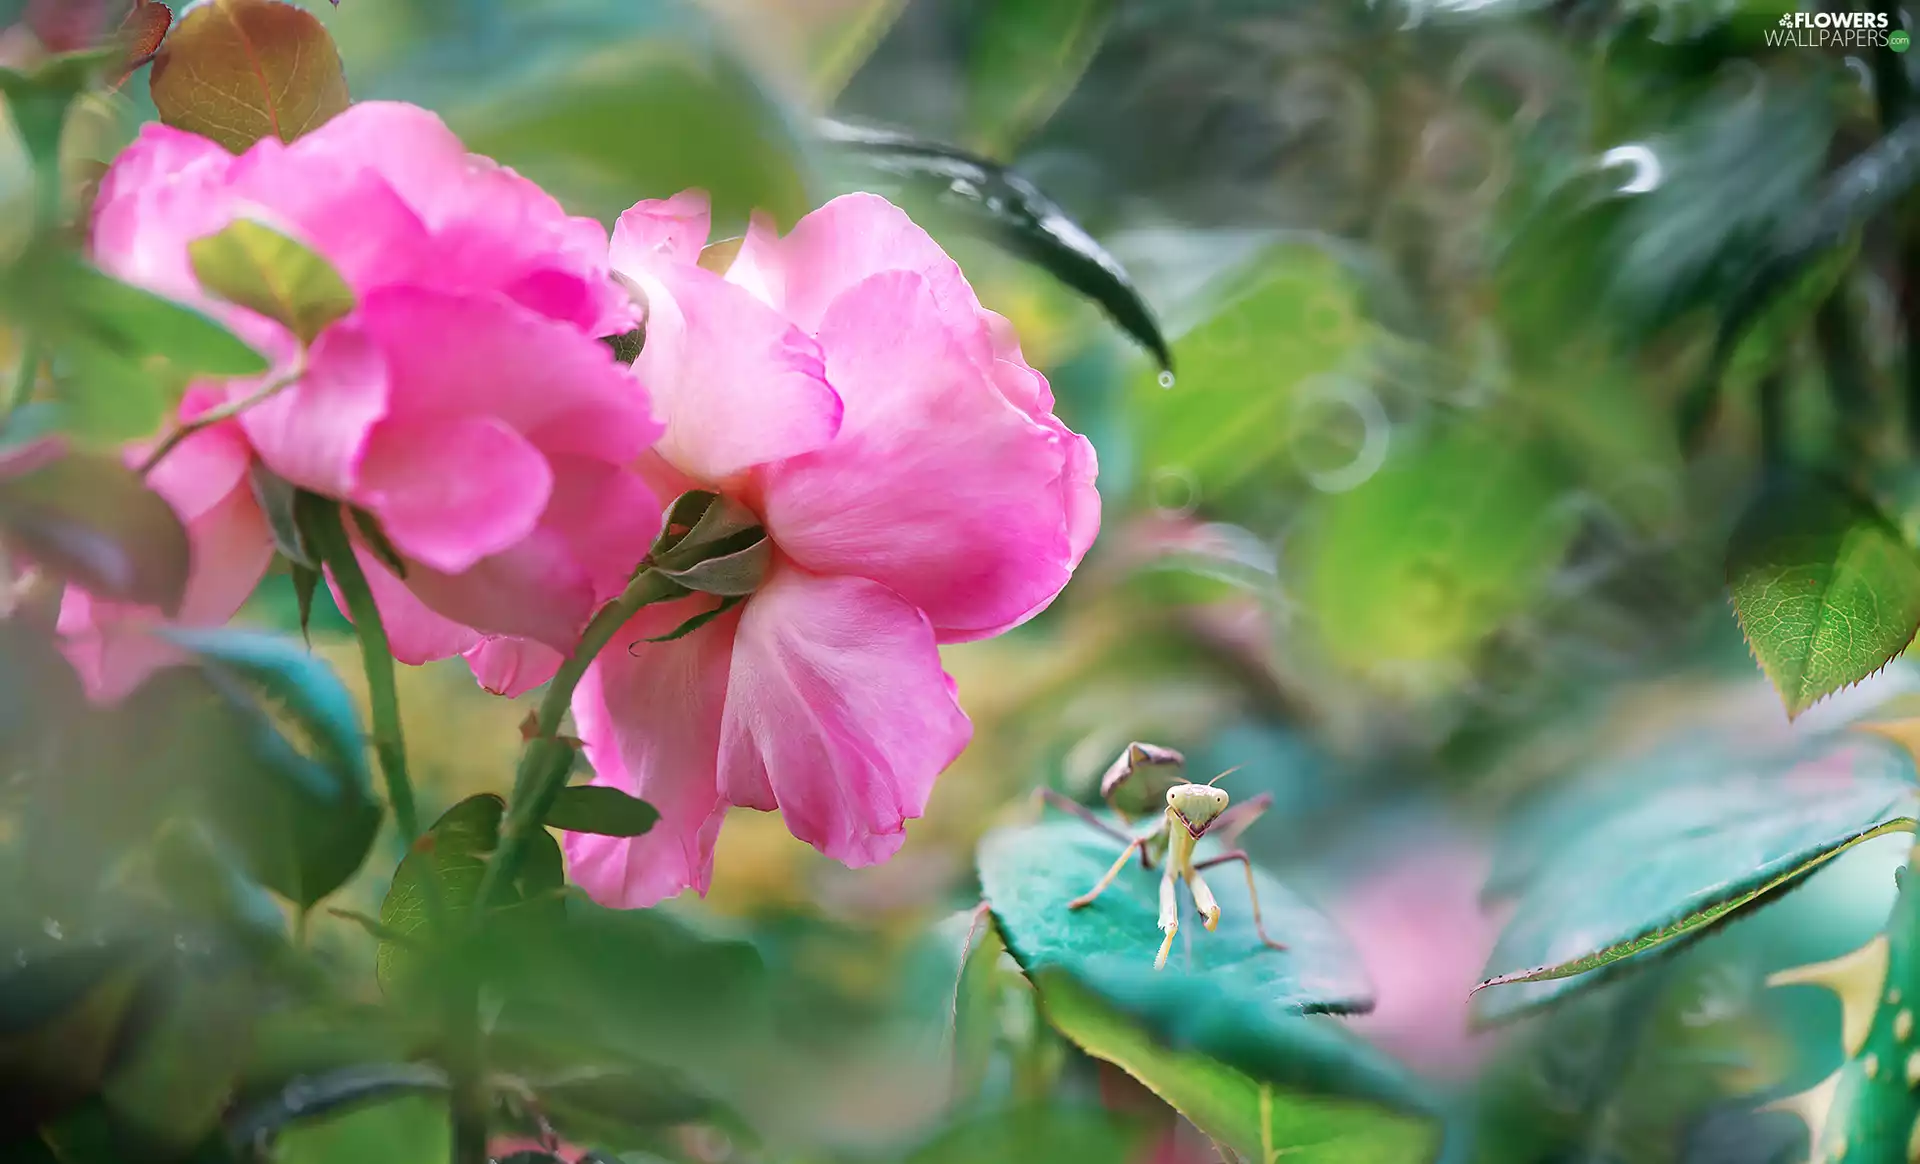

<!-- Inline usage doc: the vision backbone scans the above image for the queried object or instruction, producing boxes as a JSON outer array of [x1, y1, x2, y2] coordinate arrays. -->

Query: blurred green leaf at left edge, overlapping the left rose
[[0, 252, 267, 376]]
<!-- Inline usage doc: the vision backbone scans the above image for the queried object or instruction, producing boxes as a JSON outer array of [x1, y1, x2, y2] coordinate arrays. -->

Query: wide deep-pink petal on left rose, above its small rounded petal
[[361, 288, 664, 463]]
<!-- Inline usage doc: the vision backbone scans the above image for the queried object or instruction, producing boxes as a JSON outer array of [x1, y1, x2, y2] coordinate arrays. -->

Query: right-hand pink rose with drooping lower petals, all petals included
[[564, 192, 1100, 907]]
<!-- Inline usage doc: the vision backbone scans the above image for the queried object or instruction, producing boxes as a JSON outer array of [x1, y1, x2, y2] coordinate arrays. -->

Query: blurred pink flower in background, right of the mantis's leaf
[[1332, 834, 1500, 1078]]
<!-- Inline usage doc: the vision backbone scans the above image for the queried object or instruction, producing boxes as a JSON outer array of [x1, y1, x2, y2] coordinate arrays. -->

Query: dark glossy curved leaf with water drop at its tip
[[822, 121, 1173, 369]]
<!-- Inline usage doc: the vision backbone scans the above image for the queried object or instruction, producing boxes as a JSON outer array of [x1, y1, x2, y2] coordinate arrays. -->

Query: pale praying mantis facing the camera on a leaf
[[1041, 743, 1286, 970]]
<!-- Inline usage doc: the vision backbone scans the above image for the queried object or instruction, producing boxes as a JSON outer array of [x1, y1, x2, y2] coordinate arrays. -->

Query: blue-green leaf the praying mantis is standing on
[[979, 820, 1373, 1012]]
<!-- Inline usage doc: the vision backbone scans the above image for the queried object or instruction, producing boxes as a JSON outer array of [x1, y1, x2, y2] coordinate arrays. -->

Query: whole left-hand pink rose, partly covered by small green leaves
[[61, 102, 662, 699]]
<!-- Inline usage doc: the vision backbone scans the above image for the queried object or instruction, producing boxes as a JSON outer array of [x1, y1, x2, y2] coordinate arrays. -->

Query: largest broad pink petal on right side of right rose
[[762, 273, 1098, 642]]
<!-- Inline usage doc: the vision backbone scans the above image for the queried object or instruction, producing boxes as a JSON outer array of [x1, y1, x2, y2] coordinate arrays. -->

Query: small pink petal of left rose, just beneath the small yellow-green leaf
[[240, 321, 388, 497]]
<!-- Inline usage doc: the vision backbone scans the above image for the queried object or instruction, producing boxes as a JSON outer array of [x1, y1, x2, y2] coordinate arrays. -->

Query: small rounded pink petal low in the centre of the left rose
[[357, 417, 553, 574]]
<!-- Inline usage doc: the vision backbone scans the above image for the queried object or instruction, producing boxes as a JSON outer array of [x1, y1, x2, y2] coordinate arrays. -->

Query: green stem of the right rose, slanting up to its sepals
[[470, 563, 685, 922]]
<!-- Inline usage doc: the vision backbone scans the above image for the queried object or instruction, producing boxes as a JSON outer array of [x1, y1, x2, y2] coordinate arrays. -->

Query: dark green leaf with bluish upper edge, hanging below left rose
[[165, 628, 382, 907]]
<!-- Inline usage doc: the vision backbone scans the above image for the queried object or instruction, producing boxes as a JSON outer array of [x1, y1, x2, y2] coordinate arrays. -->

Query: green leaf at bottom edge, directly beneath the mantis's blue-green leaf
[[1037, 970, 1440, 1164]]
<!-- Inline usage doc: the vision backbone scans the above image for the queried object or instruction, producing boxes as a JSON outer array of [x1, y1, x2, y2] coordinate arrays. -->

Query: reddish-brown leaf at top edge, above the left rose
[[152, 0, 348, 154]]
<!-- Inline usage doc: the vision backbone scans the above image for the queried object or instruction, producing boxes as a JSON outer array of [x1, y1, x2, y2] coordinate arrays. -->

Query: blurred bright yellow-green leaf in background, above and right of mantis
[[1300, 418, 1576, 670]]
